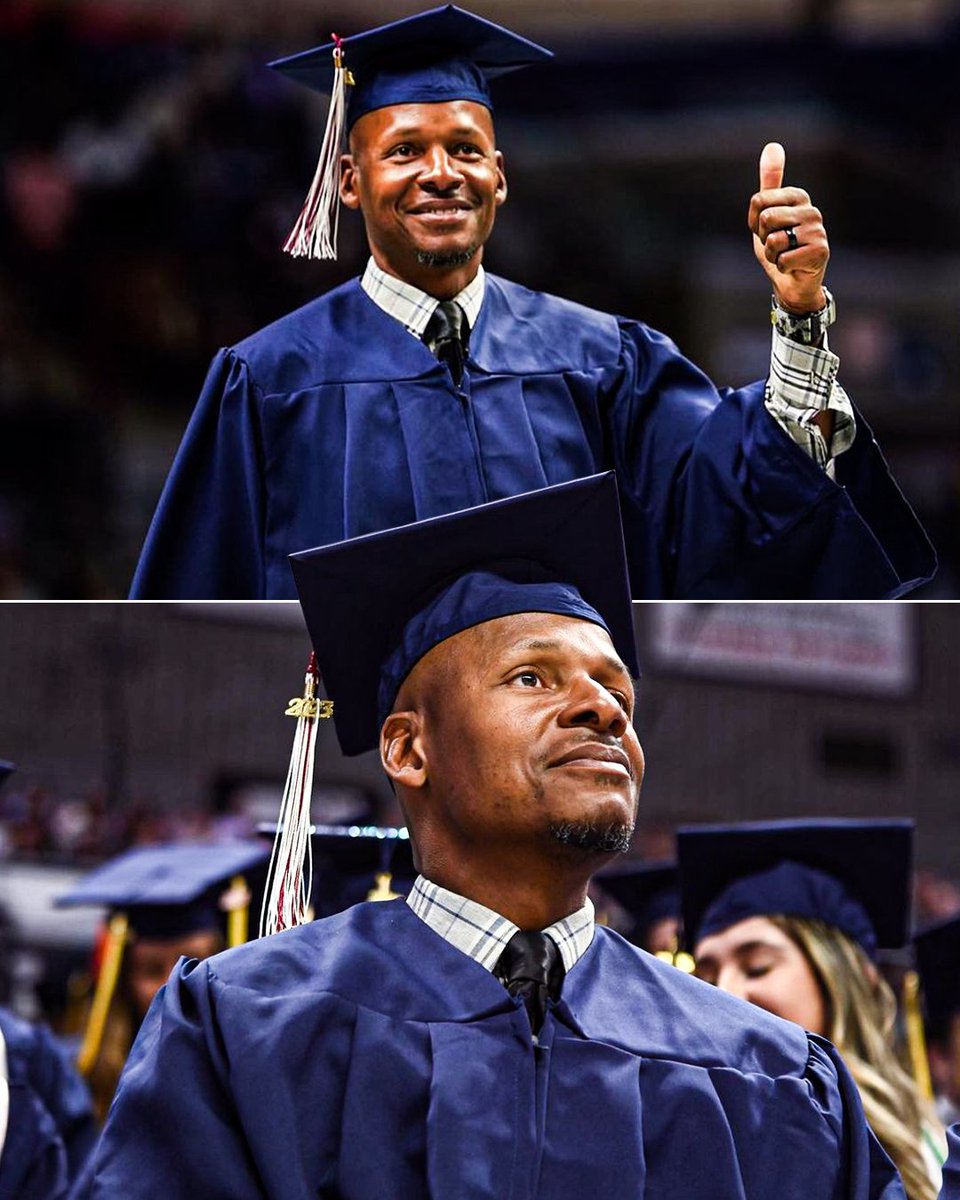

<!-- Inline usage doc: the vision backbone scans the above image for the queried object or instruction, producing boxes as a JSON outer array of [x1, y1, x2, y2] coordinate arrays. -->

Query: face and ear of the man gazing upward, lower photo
[[382, 613, 643, 894]]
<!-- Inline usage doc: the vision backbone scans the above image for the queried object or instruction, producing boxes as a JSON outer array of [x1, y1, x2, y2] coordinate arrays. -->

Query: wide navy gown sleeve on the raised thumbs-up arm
[[607, 323, 936, 600]]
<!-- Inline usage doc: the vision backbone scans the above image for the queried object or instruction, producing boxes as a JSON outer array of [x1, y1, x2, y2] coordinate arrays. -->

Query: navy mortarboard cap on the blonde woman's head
[[677, 818, 913, 958]]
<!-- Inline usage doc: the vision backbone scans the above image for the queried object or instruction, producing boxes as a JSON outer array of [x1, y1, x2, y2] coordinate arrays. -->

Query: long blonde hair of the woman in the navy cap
[[769, 917, 938, 1200]]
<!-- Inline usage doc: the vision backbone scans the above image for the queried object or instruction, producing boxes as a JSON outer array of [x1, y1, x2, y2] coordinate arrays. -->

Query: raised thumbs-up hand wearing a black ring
[[746, 142, 830, 313]]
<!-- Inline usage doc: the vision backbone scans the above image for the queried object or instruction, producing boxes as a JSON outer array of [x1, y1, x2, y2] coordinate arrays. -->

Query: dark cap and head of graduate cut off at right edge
[[913, 917, 960, 1124]]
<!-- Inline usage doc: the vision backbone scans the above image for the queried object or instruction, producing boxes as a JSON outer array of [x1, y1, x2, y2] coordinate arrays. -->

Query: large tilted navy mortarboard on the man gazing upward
[[290, 472, 640, 755]]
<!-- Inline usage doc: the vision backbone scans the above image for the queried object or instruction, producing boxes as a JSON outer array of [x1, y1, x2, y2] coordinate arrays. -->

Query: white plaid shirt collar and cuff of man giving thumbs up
[[360, 258, 857, 478]]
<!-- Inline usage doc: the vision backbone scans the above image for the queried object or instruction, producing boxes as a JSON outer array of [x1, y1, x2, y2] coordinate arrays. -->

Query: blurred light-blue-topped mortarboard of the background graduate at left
[[56, 841, 269, 941]]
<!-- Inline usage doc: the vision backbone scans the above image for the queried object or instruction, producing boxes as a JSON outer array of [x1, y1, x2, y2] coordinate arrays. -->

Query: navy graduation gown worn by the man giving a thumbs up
[[131, 275, 936, 599]]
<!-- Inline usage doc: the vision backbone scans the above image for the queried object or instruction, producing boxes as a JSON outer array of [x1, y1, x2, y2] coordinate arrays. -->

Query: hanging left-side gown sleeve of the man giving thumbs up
[[130, 350, 265, 600]]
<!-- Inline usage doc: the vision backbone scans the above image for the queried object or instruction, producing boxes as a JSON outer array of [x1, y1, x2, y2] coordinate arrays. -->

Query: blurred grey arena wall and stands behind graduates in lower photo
[[0, 602, 960, 1021]]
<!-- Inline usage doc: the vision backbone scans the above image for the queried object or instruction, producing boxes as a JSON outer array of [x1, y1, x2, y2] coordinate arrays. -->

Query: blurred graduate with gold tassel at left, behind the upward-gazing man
[[58, 841, 268, 1122]]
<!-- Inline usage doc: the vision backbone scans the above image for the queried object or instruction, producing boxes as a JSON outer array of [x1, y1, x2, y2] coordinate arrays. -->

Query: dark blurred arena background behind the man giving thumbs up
[[0, 0, 960, 597]]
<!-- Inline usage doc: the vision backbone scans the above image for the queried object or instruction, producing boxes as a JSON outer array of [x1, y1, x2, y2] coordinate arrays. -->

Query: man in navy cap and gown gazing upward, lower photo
[[94, 475, 902, 1200]]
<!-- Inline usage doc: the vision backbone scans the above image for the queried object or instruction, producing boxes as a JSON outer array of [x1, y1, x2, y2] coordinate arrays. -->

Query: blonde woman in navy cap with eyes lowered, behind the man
[[677, 821, 944, 1200]]
